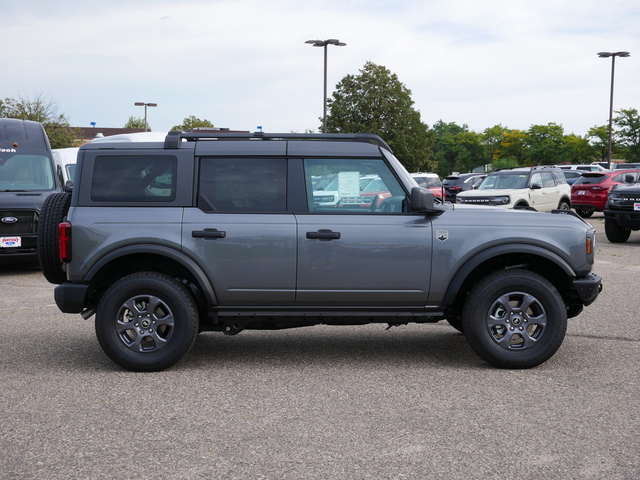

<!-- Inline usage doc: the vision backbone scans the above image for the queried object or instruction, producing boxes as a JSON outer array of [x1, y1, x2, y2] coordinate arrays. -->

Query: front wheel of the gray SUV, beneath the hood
[[462, 269, 567, 368]]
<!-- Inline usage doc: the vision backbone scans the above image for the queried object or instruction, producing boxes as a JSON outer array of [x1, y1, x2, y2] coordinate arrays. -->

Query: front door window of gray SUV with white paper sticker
[[304, 158, 408, 214]]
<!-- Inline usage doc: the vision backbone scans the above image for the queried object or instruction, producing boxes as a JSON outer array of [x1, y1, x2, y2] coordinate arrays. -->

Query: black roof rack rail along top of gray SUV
[[164, 132, 392, 152]]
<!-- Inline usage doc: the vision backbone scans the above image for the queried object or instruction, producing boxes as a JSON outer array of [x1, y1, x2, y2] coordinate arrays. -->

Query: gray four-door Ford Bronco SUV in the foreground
[[40, 132, 601, 371]]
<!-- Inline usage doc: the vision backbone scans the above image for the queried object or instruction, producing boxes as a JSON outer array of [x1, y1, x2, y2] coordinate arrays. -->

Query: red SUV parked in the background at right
[[571, 170, 640, 218]]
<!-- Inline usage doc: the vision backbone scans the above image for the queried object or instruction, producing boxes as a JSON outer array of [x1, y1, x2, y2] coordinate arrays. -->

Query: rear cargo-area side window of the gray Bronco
[[91, 155, 177, 202]]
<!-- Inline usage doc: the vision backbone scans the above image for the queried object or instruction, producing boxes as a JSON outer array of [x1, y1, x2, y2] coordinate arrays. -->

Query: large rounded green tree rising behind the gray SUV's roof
[[327, 62, 435, 172]]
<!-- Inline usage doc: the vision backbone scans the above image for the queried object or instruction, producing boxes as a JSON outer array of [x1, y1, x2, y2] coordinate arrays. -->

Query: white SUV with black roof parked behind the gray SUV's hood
[[456, 167, 571, 212]]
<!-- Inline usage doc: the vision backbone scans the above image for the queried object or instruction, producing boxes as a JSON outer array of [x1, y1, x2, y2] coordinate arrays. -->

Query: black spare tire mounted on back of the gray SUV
[[38, 192, 71, 285]]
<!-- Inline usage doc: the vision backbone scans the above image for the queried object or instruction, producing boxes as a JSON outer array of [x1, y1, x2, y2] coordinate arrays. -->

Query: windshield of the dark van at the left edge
[[0, 149, 55, 192]]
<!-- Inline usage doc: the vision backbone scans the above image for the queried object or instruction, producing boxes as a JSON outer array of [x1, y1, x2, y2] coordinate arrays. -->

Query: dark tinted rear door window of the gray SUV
[[198, 158, 287, 213]]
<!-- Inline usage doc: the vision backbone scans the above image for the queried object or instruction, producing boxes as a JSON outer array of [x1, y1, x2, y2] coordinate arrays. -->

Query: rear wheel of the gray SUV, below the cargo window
[[96, 272, 198, 372]]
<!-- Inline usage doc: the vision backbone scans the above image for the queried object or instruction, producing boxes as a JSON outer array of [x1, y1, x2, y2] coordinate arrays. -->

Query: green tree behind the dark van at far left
[[0, 94, 80, 148]]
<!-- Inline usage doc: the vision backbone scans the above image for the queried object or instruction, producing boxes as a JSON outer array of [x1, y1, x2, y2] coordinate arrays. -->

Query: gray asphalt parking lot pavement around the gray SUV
[[0, 214, 640, 480]]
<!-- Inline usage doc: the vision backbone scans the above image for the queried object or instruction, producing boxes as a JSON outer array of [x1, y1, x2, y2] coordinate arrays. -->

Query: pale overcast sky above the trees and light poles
[[5, 0, 640, 135]]
